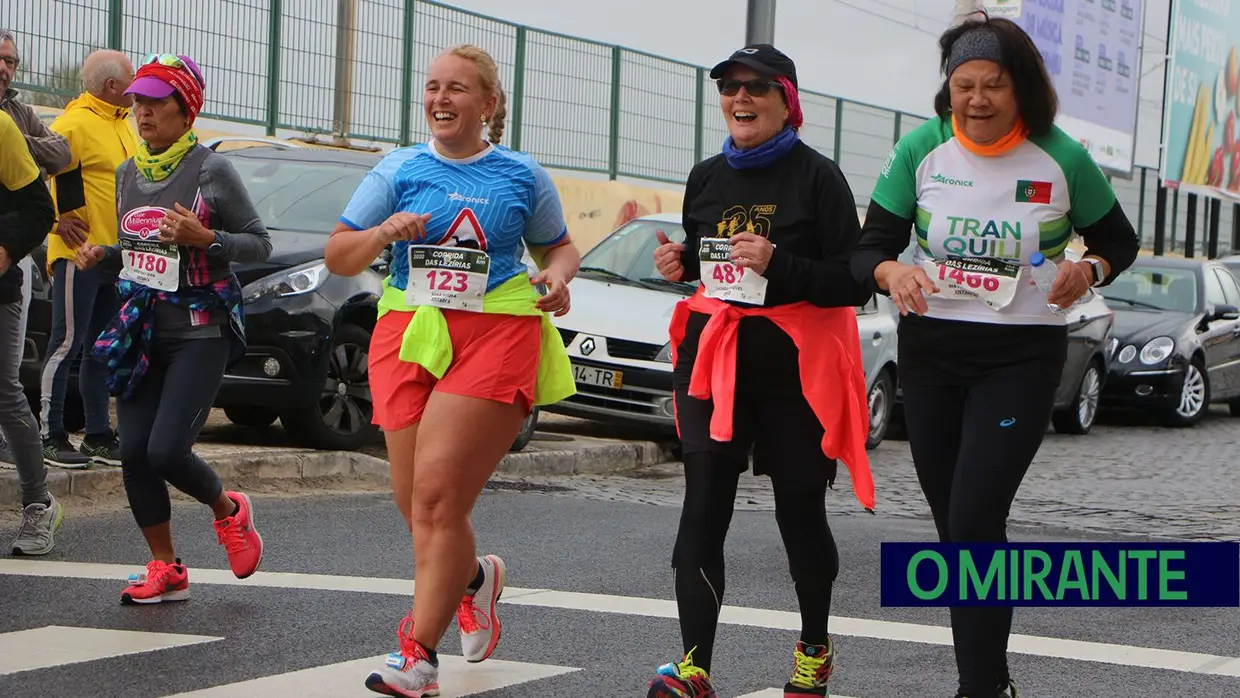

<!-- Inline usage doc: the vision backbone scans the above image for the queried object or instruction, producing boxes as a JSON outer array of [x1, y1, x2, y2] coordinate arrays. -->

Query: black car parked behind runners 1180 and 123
[[22, 138, 538, 450]]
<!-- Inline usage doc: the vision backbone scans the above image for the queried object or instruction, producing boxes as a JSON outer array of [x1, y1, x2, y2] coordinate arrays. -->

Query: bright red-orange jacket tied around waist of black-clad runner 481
[[670, 289, 874, 512]]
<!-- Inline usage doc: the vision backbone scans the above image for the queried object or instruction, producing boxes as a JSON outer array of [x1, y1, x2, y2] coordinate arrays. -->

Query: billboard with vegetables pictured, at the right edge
[[1159, 0, 1240, 200]]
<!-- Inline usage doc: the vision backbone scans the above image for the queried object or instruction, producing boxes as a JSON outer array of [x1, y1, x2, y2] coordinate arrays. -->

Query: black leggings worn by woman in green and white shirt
[[900, 369, 1058, 697]]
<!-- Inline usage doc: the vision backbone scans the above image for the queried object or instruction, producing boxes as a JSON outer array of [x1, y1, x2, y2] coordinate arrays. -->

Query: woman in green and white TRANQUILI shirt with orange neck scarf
[[852, 12, 1140, 698]]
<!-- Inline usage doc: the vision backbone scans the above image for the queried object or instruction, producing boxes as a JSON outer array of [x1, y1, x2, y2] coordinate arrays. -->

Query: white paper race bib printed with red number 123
[[404, 244, 491, 312]]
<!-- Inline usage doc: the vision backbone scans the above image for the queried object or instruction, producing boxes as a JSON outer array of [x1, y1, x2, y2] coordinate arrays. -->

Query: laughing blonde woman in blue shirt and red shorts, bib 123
[[326, 46, 580, 698]]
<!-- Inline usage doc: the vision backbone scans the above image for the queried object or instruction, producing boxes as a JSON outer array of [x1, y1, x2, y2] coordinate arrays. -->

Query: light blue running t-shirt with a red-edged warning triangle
[[340, 143, 568, 291]]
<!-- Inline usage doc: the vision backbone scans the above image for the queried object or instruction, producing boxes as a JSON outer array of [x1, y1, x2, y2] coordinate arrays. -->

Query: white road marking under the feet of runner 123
[[167, 655, 582, 698]]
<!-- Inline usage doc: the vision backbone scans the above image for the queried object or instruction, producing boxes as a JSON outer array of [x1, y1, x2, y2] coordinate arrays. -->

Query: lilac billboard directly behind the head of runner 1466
[[983, 0, 1143, 177]]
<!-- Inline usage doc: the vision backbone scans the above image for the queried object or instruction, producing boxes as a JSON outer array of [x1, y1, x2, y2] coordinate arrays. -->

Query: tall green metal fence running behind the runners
[[0, 0, 1234, 253]]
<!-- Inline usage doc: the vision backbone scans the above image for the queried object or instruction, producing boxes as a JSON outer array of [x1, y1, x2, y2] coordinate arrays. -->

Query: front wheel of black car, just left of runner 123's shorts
[[280, 325, 378, 451]]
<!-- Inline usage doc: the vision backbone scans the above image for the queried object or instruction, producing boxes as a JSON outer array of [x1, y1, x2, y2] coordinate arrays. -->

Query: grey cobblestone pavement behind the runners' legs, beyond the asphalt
[[495, 408, 1240, 541]]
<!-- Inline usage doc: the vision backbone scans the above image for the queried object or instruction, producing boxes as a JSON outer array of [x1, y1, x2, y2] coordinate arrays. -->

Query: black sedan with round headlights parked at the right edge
[[1101, 255, 1240, 426]]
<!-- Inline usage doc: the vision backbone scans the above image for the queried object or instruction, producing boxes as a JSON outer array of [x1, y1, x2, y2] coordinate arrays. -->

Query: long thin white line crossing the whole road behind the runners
[[0, 559, 1240, 678]]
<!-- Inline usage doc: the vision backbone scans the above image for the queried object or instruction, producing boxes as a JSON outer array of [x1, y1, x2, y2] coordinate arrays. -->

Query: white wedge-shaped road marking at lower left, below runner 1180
[[0, 625, 223, 676]]
